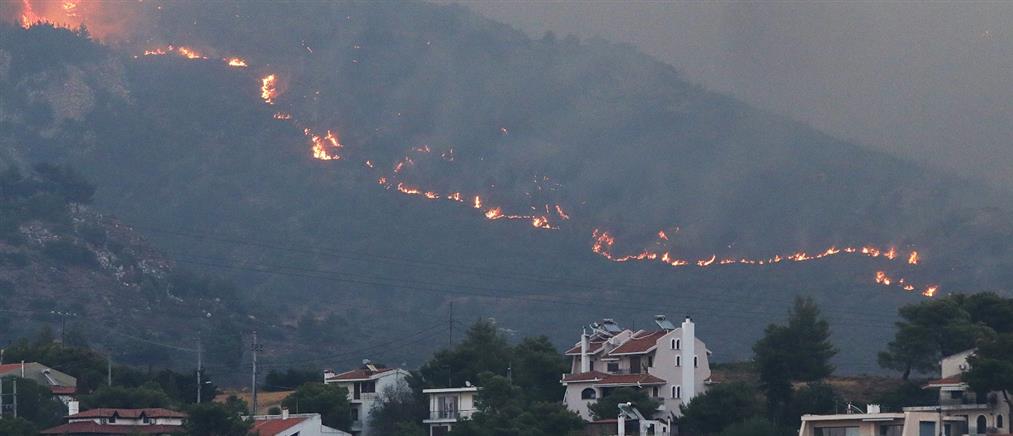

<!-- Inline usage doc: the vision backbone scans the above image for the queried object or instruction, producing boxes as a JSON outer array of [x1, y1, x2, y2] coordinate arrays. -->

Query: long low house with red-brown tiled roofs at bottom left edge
[[42, 402, 186, 435]]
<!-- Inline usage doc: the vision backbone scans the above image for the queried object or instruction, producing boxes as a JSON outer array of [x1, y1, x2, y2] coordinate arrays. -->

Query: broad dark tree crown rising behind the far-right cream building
[[878, 294, 996, 380]]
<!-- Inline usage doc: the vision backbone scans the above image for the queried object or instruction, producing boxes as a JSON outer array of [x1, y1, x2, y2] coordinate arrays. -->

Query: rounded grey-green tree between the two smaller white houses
[[370, 377, 430, 435]]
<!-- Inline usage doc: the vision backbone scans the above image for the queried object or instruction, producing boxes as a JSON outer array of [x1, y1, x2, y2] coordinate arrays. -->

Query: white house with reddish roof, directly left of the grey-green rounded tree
[[323, 360, 409, 436]]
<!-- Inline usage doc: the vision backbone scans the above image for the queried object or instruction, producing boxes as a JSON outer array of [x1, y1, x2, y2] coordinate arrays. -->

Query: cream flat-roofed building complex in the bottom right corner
[[798, 350, 1011, 436]]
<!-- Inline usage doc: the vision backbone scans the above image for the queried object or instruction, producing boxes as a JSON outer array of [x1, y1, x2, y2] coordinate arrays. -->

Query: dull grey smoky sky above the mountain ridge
[[439, 0, 1013, 190]]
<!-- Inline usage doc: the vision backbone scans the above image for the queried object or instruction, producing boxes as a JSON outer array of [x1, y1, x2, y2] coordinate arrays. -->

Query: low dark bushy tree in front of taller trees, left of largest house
[[450, 372, 583, 436]]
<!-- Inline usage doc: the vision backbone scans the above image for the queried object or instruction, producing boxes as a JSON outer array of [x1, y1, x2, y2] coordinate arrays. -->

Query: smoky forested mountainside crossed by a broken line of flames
[[0, 2, 1013, 372]]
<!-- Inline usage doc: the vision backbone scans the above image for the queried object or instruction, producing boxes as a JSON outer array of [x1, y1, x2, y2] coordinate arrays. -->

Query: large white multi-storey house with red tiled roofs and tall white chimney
[[561, 315, 710, 423]]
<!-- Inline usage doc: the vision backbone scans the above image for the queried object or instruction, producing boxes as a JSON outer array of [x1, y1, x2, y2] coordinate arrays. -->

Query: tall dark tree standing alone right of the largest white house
[[753, 297, 837, 424]]
